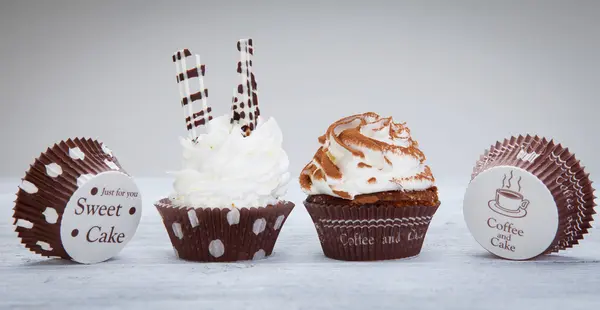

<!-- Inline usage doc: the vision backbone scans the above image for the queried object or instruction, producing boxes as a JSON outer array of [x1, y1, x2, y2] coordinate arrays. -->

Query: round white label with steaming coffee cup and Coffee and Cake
[[463, 166, 558, 260]]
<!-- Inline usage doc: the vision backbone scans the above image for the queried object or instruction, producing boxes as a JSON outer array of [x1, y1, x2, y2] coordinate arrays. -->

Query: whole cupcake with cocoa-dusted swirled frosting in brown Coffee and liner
[[300, 113, 440, 261]]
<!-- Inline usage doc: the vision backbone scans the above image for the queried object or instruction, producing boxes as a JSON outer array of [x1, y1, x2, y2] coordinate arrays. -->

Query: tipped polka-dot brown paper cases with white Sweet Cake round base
[[13, 139, 142, 264]]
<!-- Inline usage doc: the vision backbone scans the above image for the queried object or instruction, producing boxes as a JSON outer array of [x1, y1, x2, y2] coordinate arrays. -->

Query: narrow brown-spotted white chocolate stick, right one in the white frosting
[[231, 39, 260, 136]]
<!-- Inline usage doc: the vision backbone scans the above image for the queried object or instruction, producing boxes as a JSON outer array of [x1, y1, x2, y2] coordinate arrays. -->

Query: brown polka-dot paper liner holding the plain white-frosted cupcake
[[155, 198, 294, 262]]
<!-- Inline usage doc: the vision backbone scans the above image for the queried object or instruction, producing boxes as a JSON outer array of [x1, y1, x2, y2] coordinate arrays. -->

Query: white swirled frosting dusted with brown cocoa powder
[[300, 113, 435, 199]]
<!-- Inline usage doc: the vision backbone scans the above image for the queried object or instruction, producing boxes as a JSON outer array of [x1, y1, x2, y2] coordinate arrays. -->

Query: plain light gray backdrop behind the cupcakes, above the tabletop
[[0, 1, 600, 184]]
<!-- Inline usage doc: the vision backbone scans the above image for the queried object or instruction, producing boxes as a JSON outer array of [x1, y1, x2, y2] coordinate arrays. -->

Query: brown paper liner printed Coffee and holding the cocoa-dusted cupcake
[[304, 201, 438, 261]]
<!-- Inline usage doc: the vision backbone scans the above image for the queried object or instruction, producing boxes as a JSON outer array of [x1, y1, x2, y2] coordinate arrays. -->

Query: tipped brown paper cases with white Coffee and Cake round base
[[463, 135, 596, 260]]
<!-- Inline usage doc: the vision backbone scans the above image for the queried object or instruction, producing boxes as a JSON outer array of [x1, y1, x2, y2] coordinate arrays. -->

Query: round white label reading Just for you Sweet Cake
[[60, 171, 142, 264]]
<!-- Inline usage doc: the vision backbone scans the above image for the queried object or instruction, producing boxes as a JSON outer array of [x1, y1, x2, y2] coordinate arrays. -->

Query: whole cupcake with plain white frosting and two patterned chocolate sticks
[[155, 39, 294, 262]]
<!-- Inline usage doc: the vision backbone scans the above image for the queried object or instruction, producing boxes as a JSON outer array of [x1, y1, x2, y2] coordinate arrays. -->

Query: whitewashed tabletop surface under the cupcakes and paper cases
[[0, 180, 600, 310]]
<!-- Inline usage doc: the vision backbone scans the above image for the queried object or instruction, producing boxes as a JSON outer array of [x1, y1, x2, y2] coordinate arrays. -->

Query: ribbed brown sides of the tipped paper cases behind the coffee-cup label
[[472, 135, 596, 254]]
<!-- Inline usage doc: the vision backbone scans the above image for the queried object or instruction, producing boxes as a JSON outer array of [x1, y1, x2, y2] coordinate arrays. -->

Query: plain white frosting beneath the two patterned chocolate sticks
[[170, 115, 290, 208]]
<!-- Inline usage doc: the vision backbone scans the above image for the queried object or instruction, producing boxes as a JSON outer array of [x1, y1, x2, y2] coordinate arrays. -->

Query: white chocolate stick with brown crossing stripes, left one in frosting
[[173, 48, 212, 139]]
